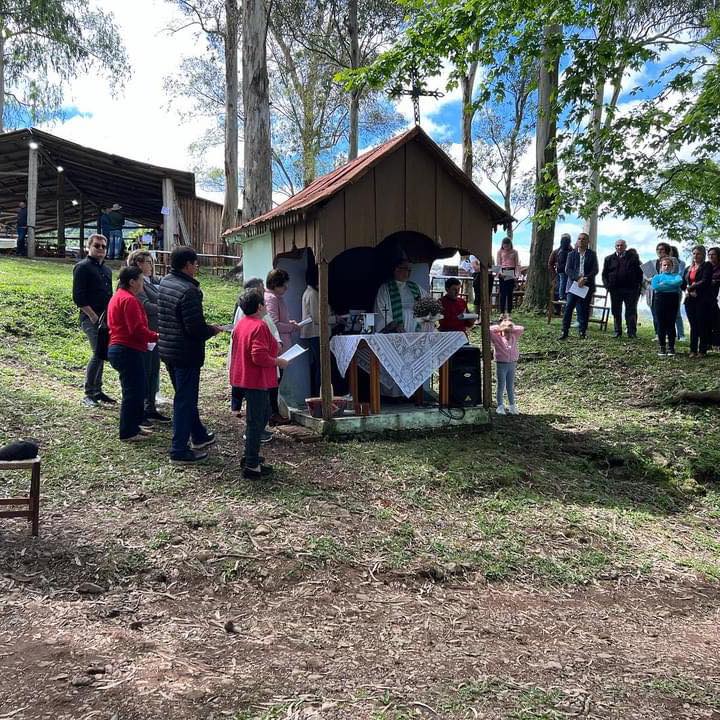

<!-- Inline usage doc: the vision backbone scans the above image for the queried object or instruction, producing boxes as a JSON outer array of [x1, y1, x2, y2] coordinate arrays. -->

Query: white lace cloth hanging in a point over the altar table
[[330, 332, 467, 398]]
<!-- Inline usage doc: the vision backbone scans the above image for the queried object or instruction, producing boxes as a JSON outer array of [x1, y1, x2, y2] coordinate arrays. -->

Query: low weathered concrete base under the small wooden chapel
[[290, 403, 490, 437]]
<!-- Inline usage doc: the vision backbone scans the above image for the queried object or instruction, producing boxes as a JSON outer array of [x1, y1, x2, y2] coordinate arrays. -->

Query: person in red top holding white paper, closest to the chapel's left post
[[230, 290, 288, 480]]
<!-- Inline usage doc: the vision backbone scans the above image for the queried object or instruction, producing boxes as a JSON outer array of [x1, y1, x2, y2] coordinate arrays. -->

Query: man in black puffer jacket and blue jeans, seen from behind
[[158, 246, 220, 462]]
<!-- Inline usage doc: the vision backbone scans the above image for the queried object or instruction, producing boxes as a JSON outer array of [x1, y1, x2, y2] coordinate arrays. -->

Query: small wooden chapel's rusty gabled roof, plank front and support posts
[[225, 126, 513, 419]]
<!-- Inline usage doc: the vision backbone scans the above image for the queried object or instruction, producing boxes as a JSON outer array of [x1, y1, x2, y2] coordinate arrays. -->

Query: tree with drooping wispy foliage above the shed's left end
[[0, 0, 125, 132]]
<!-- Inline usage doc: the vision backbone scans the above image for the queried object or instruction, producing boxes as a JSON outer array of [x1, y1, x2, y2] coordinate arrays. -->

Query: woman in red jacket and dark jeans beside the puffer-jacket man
[[107, 267, 158, 442]]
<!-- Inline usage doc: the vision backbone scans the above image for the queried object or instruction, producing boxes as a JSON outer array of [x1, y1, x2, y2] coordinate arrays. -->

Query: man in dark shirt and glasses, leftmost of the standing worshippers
[[73, 235, 115, 407]]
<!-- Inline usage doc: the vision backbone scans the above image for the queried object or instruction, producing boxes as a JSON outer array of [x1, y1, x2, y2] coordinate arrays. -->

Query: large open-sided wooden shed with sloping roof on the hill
[[0, 128, 222, 253]]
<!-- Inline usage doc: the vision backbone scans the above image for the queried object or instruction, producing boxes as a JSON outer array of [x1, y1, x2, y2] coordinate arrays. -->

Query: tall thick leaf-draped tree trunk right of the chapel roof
[[523, 25, 561, 311]]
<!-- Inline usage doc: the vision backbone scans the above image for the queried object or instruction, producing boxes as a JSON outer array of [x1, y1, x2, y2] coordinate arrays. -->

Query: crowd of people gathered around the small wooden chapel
[[73, 233, 720, 464]]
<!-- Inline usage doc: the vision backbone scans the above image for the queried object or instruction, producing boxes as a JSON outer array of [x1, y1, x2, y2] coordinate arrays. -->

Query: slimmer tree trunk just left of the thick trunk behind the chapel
[[221, 0, 240, 231]]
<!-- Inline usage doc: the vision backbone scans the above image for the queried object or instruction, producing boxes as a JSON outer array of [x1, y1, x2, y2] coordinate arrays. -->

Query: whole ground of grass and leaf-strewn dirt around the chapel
[[0, 259, 720, 720]]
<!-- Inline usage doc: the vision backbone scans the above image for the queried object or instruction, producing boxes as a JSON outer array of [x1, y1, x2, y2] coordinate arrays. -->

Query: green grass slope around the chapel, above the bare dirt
[[0, 258, 720, 587]]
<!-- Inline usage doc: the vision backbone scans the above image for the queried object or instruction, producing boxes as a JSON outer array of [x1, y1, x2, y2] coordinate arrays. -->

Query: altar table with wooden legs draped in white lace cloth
[[330, 332, 468, 415]]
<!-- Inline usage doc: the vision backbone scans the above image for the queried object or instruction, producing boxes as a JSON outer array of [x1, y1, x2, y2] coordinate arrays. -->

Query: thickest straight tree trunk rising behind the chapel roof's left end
[[242, 0, 272, 222]]
